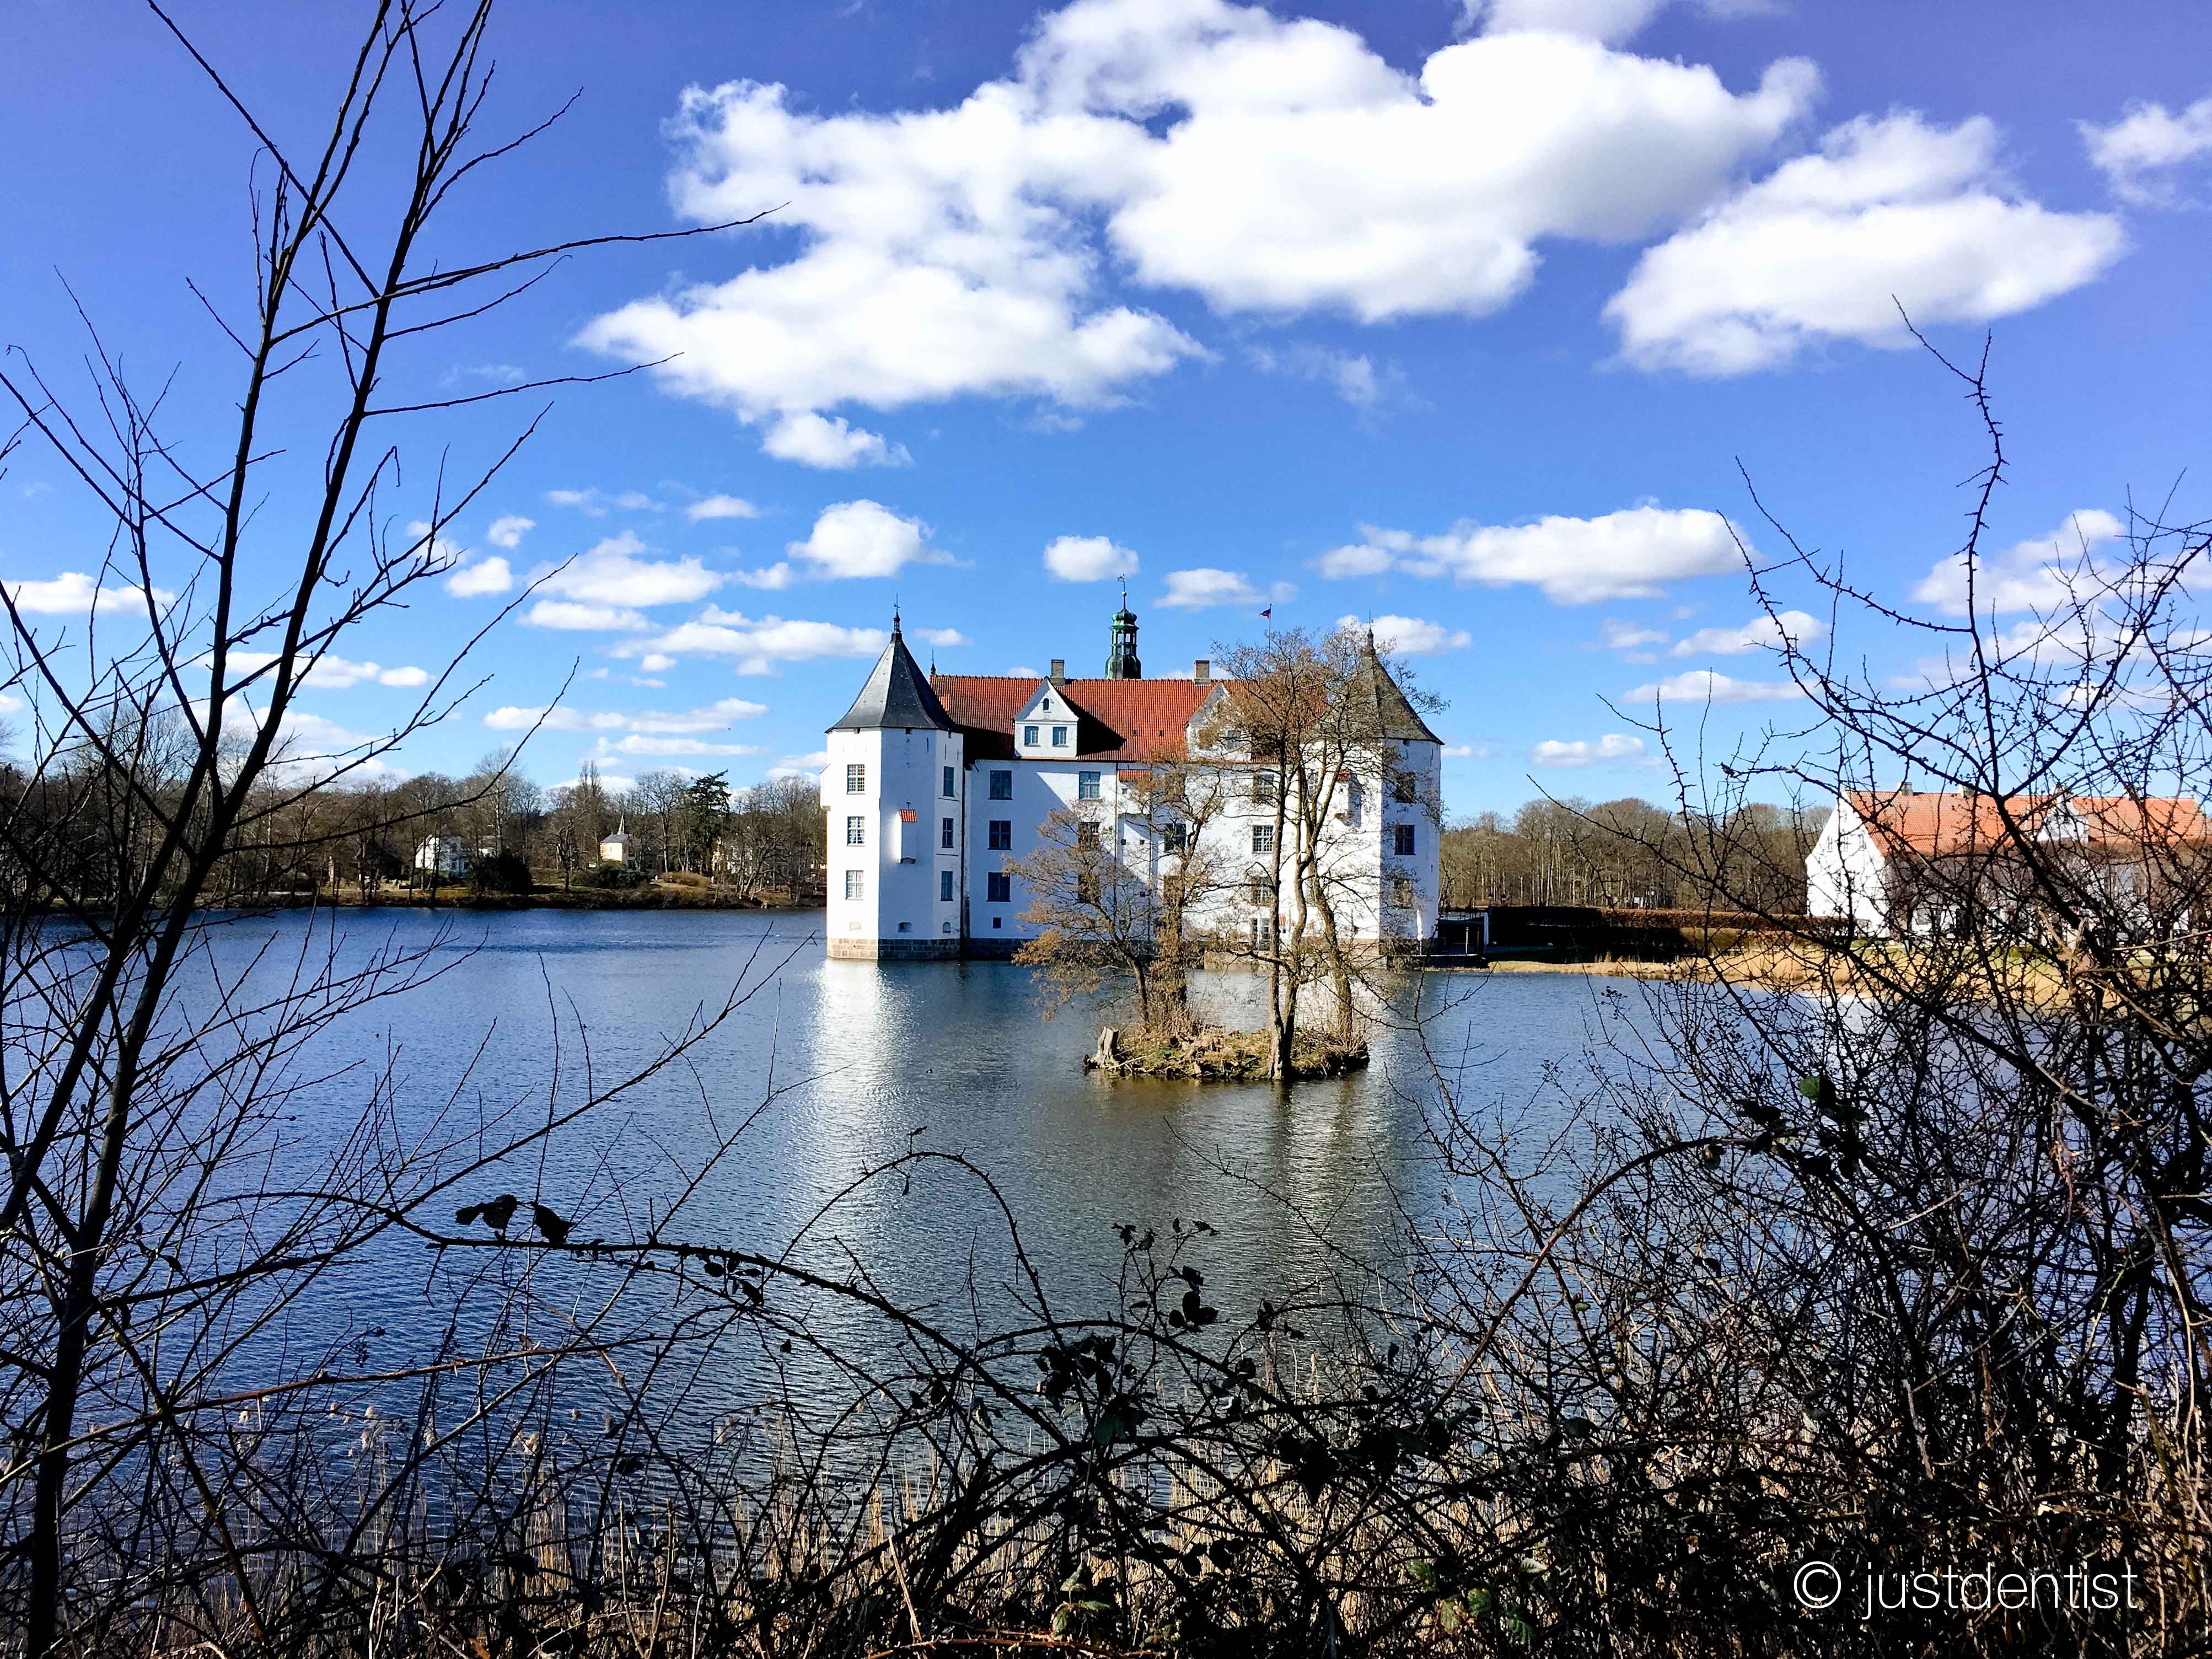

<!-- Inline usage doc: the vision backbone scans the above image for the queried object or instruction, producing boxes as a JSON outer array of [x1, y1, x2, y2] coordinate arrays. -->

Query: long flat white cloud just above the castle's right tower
[[1320, 507, 1743, 604]]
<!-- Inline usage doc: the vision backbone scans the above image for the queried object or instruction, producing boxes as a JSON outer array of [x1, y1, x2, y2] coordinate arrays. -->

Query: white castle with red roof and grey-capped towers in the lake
[[823, 599, 1442, 960]]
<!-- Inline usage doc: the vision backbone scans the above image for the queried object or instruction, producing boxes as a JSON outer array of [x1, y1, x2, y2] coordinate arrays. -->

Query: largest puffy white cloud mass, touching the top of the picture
[[582, 0, 1818, 449]]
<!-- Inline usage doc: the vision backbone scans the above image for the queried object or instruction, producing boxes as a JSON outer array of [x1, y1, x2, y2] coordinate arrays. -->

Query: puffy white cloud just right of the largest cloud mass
[[1606, 113, 2126, 374]]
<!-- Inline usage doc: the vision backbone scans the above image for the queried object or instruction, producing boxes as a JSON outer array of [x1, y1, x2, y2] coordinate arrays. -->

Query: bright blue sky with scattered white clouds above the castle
[[0, 0, 2212, 814]]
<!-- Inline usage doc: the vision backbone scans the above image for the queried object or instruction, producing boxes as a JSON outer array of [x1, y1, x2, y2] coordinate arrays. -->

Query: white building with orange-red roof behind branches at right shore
[[1805, 787, 2212, 938]]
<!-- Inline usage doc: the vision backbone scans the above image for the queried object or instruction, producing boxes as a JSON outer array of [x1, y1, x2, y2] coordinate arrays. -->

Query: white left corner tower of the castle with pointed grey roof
[[823, 610, 967, 960]]
